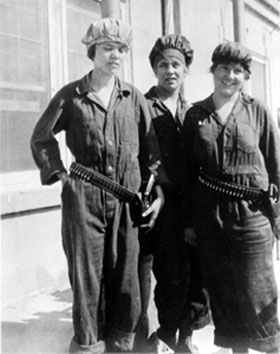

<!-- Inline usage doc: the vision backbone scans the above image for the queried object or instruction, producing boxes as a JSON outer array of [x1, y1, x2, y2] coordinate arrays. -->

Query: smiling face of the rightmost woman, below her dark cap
[[213, 63, 247, 98]]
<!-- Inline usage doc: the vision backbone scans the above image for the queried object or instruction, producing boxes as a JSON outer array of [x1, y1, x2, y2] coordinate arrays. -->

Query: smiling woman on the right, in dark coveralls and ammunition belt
[[184, 42, 280, 353]]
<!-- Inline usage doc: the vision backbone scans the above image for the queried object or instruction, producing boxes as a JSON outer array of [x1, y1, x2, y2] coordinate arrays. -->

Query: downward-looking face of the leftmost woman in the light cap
[[93, 42, 128, 76]]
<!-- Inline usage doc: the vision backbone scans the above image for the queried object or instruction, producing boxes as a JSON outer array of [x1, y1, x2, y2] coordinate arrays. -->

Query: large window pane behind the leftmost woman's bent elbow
[[0, 0, 50, 173]]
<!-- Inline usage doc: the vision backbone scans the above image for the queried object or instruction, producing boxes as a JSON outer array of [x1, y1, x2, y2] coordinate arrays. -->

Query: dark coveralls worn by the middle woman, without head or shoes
[[141, 87, 209, 346]]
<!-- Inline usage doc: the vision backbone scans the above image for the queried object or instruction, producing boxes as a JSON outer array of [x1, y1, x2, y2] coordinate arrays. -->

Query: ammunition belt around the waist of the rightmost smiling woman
[[198, 170, 267, 201]]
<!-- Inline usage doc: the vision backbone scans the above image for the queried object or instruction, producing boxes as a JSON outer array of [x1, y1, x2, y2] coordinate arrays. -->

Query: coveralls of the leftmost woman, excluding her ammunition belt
[[31, 74, 162, 353]]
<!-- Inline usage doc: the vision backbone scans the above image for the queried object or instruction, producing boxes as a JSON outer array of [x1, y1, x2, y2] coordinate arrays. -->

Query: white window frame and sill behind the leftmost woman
[[0, 0, 70, 216]]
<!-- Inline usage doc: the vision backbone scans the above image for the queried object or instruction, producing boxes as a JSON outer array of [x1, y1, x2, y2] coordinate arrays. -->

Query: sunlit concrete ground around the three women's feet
[[1, 250, 280, 354]]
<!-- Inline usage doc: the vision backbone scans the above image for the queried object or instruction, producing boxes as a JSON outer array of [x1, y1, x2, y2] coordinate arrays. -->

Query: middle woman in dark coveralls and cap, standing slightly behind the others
[[136, 35, 209, 353]]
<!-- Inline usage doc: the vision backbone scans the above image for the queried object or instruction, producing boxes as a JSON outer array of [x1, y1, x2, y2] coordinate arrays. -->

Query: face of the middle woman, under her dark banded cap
[[154, 57, 187, 92]]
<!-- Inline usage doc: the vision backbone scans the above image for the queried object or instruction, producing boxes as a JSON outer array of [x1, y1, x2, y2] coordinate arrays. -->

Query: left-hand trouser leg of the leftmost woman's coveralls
[[62, 180, 105, 354]]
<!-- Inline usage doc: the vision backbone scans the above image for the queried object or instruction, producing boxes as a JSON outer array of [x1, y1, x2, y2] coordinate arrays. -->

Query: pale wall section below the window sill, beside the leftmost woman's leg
[[1, 208, 68, 305]]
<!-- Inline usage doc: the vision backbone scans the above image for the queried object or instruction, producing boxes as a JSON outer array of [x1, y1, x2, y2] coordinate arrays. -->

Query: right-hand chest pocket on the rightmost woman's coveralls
[[236, 123, 258, 153]]
